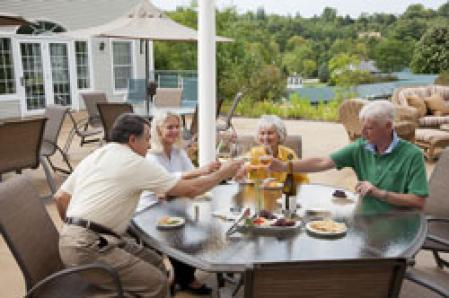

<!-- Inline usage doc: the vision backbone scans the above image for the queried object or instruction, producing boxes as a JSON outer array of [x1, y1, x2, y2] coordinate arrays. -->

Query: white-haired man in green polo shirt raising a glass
[[270, 100, 429, 212]]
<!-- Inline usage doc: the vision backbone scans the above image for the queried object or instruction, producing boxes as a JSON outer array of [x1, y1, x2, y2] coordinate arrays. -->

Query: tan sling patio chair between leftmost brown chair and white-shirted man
[[41, 105, 73, 174]]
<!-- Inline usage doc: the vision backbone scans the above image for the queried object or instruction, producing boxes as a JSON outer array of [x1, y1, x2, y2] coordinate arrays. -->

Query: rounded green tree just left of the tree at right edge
[[374, 38, 413, 72]]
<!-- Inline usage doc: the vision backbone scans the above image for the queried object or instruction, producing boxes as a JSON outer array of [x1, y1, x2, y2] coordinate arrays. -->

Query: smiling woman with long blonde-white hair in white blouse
[[147, 111, 220, 295]]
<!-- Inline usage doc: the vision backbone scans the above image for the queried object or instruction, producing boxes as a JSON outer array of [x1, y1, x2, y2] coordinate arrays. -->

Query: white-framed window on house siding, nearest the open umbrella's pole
[[112, 41, 133, 90]]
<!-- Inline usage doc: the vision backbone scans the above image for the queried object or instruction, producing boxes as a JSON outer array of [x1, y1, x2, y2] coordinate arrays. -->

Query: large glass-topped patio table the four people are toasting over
[[133, 184, 427, 272]]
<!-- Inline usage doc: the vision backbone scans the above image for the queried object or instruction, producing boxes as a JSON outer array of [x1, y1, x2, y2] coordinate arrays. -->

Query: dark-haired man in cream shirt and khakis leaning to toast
[[55, 114, 241, 297]]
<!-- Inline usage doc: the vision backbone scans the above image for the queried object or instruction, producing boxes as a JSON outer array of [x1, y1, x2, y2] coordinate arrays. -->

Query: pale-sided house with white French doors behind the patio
[[0, 0, 154, 119]]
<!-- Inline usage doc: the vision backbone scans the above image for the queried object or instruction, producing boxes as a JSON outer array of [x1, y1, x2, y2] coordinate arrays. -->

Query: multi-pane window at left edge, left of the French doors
[[0, 38, 16, 94]]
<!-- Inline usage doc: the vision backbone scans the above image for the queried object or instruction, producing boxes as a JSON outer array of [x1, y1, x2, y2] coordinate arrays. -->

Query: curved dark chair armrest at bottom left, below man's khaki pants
[[25, 262, 123, 297]]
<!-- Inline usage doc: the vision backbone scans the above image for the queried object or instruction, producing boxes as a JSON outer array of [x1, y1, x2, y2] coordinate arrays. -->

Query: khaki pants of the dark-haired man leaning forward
[[59, 224, 168, 297]]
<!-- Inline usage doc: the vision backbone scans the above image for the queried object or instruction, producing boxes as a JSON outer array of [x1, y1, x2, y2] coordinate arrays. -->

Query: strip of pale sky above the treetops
[[150, 0, 447, 17]]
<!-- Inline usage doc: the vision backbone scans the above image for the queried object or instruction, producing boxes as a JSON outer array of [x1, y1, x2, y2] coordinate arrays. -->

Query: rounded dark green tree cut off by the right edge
[[410, 26, 449, 73]]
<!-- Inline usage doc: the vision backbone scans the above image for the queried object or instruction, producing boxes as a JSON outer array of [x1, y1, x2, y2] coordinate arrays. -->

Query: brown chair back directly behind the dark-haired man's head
[[97, 102, 133, 142]]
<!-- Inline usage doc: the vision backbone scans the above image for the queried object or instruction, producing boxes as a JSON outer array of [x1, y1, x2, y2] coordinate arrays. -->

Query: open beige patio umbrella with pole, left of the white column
[[63, 0, 232, 113]]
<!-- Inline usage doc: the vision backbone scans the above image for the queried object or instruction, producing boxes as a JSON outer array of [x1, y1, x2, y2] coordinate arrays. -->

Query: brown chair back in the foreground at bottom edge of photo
[[245, 259, 406, 298]]
